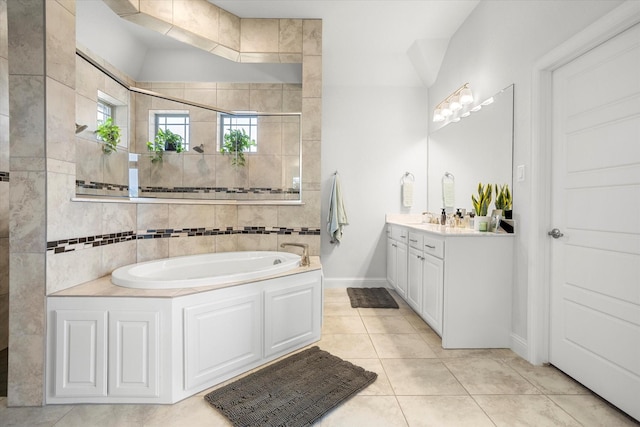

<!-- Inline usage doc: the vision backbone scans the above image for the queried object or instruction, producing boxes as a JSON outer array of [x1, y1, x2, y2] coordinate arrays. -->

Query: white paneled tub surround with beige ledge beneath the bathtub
[[46, 257, 322, 404]]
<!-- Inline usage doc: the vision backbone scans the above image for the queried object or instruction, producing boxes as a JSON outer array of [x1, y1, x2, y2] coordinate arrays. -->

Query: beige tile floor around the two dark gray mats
[[0, 289, 640, 427]]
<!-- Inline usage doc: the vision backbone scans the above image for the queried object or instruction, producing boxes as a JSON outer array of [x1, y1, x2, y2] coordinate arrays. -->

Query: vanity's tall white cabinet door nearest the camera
[[421, 255, 444, 335]]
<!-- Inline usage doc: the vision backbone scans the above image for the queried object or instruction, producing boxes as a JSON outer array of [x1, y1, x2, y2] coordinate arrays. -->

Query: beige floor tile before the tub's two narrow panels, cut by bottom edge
[[56, 405, 148, 427]]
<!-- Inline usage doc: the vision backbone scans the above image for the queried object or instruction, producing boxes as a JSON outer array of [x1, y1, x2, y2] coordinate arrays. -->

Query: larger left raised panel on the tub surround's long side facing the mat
[[184, 294, 262, 390]]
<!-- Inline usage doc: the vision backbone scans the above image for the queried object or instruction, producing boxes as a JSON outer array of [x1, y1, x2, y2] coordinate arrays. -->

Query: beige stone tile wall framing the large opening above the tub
[[6, 0, 322, 406]]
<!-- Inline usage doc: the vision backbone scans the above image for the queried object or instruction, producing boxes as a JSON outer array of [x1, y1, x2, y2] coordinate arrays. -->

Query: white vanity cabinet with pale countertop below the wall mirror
[[387, 215, 513, 348]]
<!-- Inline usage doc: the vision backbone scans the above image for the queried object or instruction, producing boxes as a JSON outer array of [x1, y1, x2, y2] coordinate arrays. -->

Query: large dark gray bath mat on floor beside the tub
[[204, 347, 378, 427]]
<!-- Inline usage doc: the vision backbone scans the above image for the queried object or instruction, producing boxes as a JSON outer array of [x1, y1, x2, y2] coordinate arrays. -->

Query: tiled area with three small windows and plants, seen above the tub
[[76, 2, 302, 203]]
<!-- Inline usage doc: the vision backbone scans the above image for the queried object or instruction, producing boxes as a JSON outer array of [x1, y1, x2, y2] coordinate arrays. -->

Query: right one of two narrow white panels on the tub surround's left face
[[109, 311, 160, 397]]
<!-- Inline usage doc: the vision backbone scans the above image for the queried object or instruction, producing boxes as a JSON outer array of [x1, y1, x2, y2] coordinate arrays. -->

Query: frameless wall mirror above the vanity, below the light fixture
[[427, 85, 513, 213]]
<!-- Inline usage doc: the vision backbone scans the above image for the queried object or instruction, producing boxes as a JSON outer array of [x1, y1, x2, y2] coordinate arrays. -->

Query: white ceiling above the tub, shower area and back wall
[[76, 0, 480, 87]]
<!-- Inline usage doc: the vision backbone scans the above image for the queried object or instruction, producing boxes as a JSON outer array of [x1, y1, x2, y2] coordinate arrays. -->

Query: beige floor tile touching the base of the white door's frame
[[506, 358, 591, 394]]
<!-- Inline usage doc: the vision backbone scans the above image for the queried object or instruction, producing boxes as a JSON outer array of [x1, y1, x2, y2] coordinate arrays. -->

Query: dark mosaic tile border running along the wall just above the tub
[[47, 227, 321, 254]]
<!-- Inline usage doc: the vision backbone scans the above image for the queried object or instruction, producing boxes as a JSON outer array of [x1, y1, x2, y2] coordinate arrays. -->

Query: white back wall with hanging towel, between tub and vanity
[[321, 85, 427, 286]]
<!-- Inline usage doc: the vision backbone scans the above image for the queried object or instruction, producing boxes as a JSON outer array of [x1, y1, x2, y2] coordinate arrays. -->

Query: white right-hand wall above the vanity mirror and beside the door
[[429, 0, 621, 352]]
